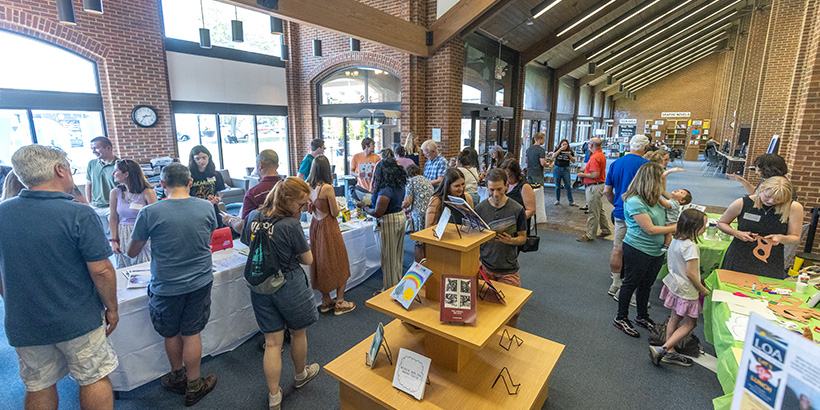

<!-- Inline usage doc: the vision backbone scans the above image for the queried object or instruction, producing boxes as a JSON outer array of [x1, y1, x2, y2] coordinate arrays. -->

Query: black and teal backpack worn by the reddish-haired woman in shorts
[[244, 213, 285, 294]]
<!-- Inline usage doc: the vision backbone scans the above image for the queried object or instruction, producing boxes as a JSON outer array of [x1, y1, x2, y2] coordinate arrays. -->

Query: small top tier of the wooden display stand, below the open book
[[410, 224, 495, 302]]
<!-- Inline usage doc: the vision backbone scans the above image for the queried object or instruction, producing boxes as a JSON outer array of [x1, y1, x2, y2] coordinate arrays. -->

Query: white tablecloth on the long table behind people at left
[[110, 221, 381, 391]]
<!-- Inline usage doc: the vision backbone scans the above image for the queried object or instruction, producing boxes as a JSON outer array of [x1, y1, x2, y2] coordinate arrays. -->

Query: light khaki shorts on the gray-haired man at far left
[[16, 324, 119, 392]]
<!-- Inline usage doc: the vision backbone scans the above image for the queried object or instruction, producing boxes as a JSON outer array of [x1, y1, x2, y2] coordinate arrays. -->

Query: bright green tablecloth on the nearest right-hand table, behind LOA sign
[[703, 272, 820, 410]]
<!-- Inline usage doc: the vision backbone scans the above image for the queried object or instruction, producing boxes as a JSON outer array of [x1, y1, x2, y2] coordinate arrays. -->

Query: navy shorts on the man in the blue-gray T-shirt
[[148, 282, 213, 338]]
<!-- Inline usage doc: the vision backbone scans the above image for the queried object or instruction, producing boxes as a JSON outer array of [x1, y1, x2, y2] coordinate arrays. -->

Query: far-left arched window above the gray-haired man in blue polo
[[0, 30, 105, 177]]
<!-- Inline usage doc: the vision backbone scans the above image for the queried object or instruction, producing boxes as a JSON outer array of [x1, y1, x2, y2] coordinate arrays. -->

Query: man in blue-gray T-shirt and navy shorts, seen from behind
[[128, 164, 217, 406]]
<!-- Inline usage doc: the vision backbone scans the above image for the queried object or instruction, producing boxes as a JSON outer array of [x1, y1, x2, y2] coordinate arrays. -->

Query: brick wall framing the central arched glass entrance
[[285, 0, 464, 171]]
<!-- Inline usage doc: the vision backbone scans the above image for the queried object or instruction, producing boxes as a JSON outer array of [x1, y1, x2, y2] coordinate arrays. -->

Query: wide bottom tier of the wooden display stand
[[324, 317, 564, 410]]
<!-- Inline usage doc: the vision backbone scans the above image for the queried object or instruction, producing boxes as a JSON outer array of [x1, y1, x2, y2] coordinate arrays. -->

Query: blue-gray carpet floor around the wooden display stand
[[0, 230, 722, 410]]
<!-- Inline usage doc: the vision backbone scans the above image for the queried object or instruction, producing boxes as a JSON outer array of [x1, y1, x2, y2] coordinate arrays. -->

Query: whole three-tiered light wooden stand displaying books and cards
[[325, 224, 564, 410]]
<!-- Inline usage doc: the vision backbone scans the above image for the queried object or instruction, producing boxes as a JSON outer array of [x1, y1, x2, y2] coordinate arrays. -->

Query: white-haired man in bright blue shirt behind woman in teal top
[[604, 134, 649, 300]]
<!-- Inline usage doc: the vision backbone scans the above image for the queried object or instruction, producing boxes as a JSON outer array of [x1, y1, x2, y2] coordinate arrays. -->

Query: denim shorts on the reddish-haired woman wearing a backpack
[[251, 266, 319, 333]]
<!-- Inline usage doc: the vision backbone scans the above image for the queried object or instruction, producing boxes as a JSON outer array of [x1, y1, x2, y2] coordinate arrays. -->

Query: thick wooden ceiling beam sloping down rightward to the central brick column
[[218, 0, 430, 57]]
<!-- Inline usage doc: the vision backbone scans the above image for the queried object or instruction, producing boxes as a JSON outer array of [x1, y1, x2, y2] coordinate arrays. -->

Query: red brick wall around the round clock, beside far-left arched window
[[0, 0, 176, 161]]
